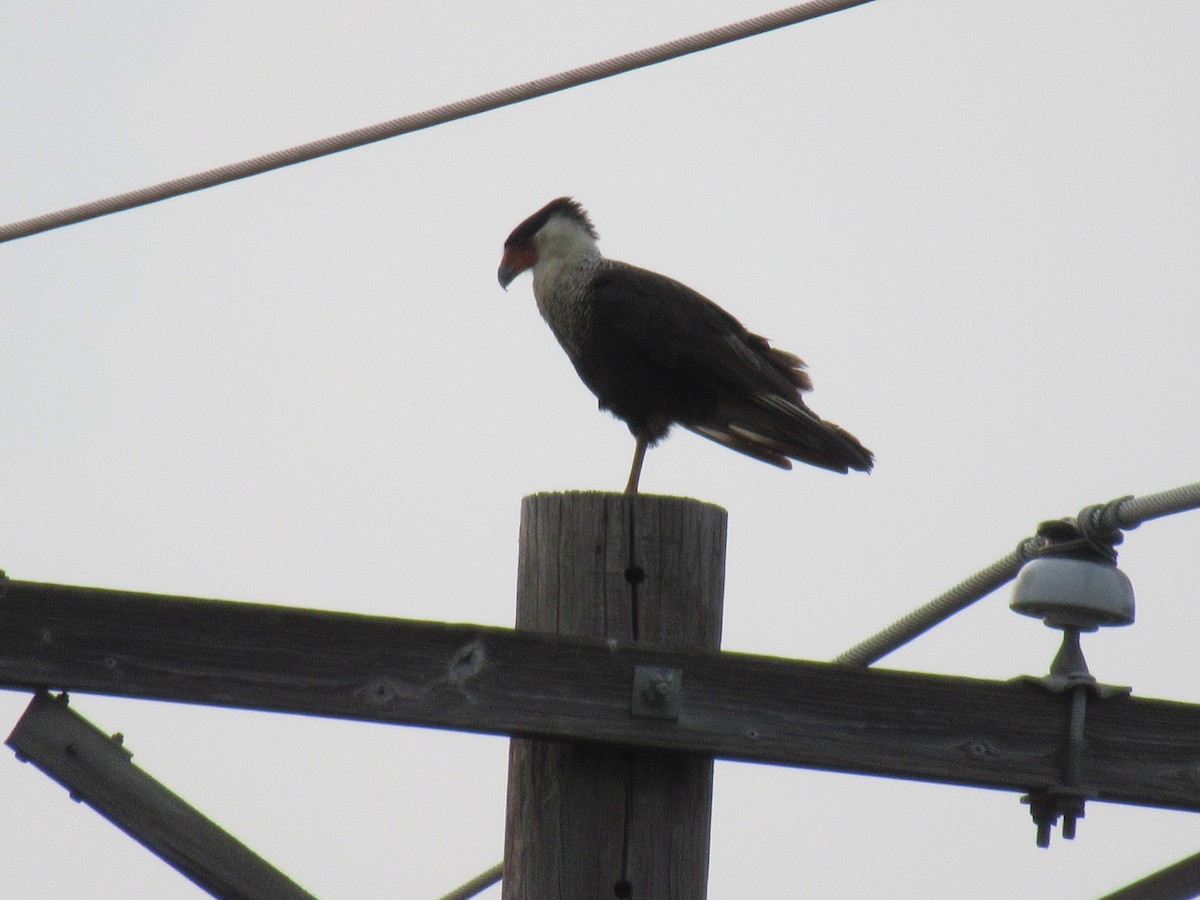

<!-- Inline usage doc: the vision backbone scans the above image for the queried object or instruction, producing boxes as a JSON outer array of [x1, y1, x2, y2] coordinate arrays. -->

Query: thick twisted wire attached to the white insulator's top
[[833, 481, 1200, 666]]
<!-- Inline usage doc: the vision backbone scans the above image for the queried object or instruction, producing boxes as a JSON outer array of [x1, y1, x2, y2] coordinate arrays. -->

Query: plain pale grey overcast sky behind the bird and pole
[[0, 0, 1200, 900]]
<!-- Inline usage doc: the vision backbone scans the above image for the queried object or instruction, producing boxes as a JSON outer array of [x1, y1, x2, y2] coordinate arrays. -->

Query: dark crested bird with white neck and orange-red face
[[497, 197, 875, 494]]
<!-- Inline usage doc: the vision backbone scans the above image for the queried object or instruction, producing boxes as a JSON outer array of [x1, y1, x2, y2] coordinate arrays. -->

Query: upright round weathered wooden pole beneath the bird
[[503, 493, 726, 900]]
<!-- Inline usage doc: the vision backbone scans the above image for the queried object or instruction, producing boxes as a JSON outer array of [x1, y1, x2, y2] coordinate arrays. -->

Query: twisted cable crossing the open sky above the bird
[[0, 0, 871, 244]]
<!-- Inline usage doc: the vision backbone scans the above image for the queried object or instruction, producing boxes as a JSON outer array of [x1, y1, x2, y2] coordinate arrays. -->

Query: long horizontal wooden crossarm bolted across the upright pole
[[0, 581, 1200, 810]]
